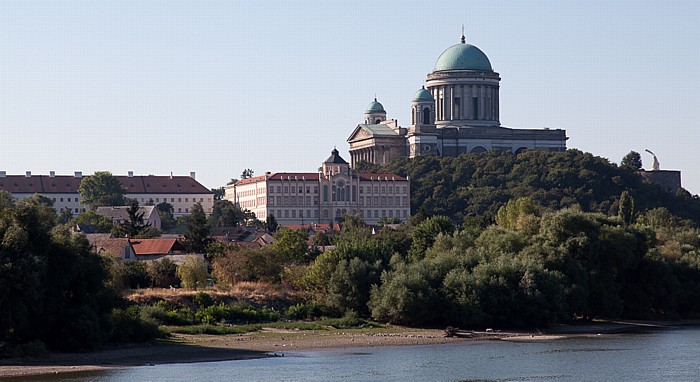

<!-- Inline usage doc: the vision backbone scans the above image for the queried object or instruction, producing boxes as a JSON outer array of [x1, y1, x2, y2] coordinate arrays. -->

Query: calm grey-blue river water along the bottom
[[12, 328, 700, 382]]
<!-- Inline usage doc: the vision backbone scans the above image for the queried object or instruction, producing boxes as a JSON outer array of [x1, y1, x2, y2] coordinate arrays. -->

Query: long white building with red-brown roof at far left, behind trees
[[0, 171, 214, 217]]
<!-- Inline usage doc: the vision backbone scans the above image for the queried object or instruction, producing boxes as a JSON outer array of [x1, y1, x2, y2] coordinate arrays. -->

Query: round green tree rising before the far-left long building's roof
[[78, 171, 126, 209]]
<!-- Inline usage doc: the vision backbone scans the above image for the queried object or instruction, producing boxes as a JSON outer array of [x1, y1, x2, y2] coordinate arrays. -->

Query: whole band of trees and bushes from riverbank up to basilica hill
[[0, 150, 700, 356]]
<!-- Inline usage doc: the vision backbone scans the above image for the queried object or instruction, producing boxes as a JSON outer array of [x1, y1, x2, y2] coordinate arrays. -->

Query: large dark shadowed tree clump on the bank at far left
[[0, 192, 116, 351]]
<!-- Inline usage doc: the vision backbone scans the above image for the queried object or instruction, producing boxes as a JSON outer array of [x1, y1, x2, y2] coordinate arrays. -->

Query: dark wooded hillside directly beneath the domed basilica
[[359, 150, 700, 225]]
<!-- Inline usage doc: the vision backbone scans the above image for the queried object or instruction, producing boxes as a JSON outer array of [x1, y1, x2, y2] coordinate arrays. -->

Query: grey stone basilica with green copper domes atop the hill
[[348, 35, 568, 167]]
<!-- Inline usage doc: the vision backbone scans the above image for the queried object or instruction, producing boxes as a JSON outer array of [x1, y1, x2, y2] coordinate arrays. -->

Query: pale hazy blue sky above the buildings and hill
[[0, 0, 700, 194]]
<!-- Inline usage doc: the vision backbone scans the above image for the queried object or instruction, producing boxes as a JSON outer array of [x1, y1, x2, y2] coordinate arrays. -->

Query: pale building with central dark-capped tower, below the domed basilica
[[224, 149, 411, 225]]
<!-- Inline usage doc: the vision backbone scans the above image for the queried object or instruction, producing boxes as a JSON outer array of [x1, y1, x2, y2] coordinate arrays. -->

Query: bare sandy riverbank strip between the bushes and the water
[[0, 321, 700, 378]]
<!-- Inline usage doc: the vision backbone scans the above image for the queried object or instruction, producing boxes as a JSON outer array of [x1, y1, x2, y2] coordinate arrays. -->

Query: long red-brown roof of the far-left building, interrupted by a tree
[[0, 175, 212, 194]]
